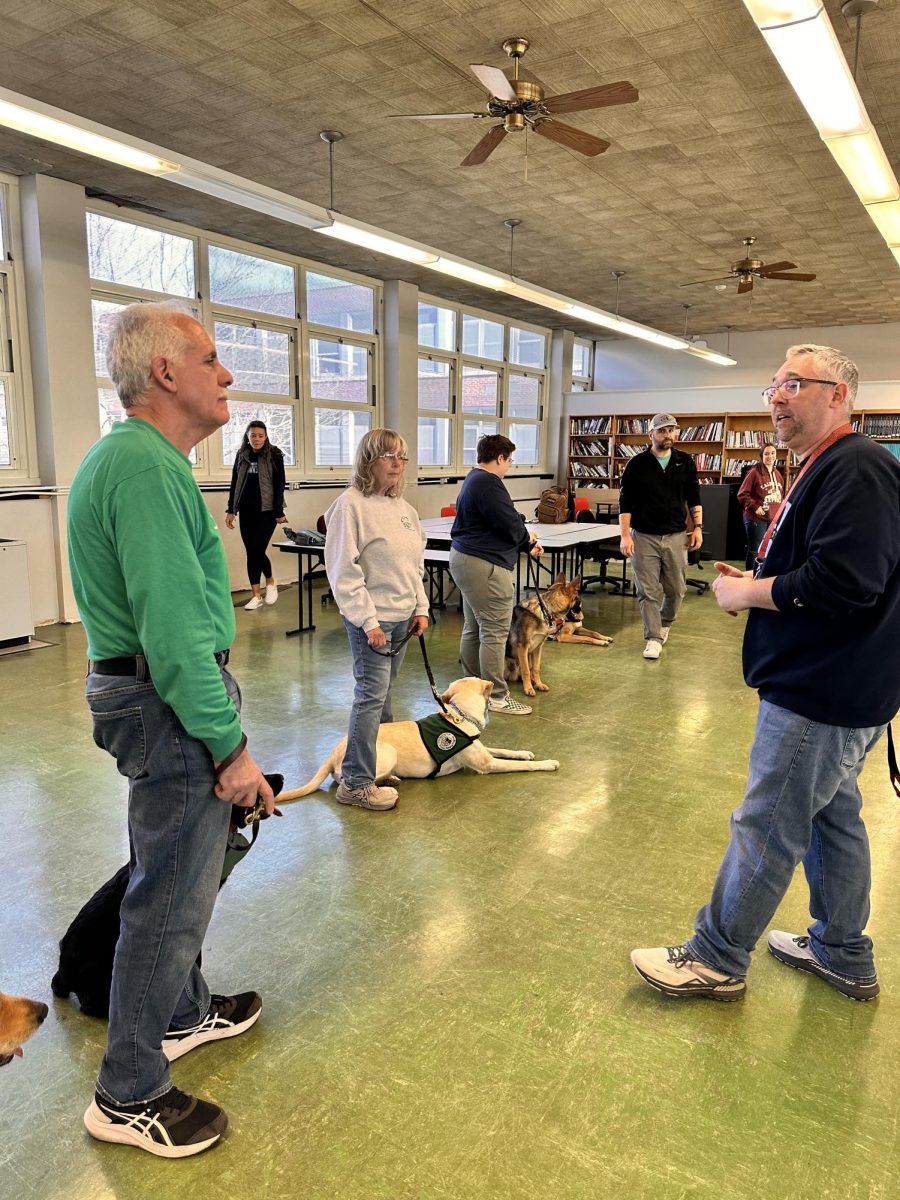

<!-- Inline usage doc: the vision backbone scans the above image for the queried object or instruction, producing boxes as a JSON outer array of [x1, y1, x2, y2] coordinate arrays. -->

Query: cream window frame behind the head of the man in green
[[90, 199, 384, 484]]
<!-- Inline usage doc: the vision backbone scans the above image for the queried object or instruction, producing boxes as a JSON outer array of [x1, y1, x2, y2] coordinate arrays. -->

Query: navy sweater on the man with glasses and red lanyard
[[744, 433, 900, 728]]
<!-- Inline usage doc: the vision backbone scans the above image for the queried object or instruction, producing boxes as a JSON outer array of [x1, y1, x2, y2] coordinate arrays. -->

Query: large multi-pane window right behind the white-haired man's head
[[90, 204, 386, 480]]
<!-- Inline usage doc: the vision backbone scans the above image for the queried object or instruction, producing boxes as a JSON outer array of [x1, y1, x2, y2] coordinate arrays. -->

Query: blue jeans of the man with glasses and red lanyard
[[689, 700, 886, 982]]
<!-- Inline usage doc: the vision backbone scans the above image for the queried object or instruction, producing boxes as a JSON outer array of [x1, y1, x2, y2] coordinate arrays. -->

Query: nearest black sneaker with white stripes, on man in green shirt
[[84, 1087, 228, 1158]]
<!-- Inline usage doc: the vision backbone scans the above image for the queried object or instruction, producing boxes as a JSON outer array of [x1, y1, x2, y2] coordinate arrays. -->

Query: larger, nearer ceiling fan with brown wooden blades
[[390, 37, 637, 167]]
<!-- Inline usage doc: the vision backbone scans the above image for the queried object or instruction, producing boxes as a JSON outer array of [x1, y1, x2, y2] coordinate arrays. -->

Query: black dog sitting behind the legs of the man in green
[[50, 775, 284, 1020]]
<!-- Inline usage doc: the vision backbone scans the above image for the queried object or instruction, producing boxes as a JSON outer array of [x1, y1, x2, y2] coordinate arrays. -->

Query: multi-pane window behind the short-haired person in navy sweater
[[418, 298, 550, 475]]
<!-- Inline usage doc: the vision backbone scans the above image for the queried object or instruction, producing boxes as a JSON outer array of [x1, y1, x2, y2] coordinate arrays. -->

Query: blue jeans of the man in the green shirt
[[86, 668, 241, 1104]]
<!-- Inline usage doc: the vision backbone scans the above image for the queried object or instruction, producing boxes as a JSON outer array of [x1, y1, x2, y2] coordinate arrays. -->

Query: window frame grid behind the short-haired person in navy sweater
[[416, 292, 552, 480]]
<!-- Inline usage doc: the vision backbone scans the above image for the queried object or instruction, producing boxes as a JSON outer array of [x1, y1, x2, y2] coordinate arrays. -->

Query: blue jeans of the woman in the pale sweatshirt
[[341, 613, 415, 787]]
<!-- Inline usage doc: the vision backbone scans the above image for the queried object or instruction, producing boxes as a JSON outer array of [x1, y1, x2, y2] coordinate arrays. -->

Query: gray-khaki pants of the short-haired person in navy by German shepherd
[[450, 550, 516, 700]]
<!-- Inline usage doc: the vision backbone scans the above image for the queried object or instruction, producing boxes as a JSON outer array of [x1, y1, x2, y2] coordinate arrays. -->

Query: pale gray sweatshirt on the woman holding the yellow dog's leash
[[325, 487, 428, 632]]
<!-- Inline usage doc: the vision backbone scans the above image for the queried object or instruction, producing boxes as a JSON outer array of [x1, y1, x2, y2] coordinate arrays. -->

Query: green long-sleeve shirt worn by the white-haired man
[[68, 418, 241, 761]]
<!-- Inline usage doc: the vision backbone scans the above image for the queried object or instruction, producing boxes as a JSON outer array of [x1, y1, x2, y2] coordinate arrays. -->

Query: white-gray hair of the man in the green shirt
[[107, 301, 193, 408]]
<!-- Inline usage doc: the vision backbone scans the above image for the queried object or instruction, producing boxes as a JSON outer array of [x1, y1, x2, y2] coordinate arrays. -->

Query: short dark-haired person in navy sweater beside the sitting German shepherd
[[450, 433, 541, 716]]
